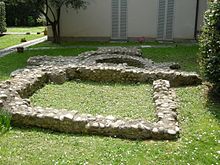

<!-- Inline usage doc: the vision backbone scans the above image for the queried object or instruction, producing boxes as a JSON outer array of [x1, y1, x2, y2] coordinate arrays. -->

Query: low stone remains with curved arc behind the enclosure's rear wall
[[28, 47, 180, 70]]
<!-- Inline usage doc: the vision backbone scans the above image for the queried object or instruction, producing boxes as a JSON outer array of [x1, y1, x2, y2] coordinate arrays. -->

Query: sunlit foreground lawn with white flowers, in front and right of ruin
[[0, 86, 220, 165]]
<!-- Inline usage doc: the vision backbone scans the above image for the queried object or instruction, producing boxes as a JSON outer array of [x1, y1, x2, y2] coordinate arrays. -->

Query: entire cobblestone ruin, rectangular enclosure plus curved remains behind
[[0, 48, 201, 140]]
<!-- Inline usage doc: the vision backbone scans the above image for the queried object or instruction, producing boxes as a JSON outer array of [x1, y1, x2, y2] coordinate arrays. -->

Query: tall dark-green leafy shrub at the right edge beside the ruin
[[199, 0, 220, 92]]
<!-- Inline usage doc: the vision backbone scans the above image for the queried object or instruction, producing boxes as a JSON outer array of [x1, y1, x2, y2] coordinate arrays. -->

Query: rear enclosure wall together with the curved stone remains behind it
[[25, 48, 202, 87]]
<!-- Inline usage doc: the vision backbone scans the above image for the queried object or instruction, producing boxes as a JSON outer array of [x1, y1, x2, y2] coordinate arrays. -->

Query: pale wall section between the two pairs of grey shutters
[[128, 0, 158, 38]]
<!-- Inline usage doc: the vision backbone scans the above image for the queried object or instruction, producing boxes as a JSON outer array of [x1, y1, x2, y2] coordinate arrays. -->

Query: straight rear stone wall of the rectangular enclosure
[[64, 65, 201, 87]]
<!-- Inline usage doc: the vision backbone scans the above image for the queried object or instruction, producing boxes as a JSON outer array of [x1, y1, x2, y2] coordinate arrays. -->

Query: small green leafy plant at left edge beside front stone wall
[[0, 109, 11, 133]]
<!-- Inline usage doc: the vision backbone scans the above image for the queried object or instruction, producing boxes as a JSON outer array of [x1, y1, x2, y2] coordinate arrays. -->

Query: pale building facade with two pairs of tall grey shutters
[[48, 0, 207, 41]]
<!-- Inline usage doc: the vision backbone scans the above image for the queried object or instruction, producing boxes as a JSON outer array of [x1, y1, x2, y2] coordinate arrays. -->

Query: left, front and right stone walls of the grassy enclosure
[[0, 66, 179, 140]]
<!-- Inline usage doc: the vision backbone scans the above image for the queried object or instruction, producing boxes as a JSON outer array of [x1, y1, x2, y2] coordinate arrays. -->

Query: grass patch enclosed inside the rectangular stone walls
[[31, 81, 155, 121]]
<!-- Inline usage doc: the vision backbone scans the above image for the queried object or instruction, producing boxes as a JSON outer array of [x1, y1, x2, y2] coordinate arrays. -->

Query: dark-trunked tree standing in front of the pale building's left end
[[28, 0, 88, 43]]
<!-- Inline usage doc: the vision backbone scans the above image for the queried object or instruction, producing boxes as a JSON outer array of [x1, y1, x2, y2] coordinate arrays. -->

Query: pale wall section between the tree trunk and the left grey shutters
[[60, 0, 111, 37]]
